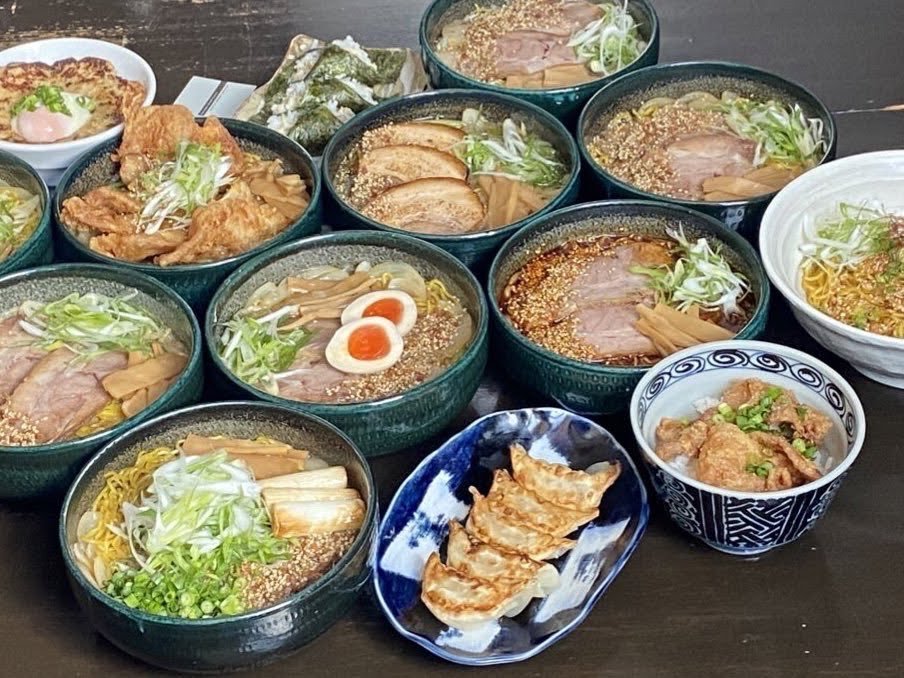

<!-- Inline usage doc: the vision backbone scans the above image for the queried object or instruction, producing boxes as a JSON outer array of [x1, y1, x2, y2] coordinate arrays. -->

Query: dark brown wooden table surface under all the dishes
[[0, 0, 904, 677]]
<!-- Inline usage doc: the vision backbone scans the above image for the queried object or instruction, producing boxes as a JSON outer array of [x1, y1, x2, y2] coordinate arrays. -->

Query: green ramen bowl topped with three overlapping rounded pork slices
[[323, 90, 580, 268]]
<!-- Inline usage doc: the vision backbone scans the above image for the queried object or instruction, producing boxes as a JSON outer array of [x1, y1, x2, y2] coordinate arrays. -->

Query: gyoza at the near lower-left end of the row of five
[[421, 553, 533, 629]]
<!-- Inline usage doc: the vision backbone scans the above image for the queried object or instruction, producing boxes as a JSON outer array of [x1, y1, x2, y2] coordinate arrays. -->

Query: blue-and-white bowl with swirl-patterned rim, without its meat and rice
[[637, 349, 855, 555]]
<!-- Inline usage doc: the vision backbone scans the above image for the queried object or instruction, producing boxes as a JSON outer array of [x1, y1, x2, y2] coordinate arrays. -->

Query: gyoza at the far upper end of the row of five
[[509, 443, 621, 511]]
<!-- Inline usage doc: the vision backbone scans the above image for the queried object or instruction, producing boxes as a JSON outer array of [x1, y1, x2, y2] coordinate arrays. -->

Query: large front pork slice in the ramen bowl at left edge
[[7, 348, 128, 443]]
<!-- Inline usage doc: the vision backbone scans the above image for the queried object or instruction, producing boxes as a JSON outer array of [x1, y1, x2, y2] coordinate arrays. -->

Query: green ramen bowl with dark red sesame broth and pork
[[488, 200, 769, 415]]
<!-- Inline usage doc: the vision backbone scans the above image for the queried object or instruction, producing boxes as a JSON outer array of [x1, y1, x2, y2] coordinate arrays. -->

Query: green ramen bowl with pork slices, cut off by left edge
[[0, 264, 202, 499]]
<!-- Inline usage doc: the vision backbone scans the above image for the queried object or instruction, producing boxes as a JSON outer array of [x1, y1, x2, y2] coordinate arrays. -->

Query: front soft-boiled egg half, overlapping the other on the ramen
[[326, 316, 405, 374]]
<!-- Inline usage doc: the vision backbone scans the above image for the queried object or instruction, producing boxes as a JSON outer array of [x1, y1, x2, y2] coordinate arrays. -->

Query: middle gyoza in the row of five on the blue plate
[[466, 487, 575, 560]]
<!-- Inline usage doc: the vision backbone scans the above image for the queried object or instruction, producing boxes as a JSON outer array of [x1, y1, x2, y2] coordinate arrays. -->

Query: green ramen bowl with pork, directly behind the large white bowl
[[577, 61, 836, 238]]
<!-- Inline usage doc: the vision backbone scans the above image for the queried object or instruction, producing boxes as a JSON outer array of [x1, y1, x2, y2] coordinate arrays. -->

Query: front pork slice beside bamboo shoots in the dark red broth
[[574, 302, 658, 358]]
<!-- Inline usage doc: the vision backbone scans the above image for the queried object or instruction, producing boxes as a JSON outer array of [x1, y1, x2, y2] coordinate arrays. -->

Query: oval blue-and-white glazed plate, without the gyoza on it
[[374, 408, 649, 665]]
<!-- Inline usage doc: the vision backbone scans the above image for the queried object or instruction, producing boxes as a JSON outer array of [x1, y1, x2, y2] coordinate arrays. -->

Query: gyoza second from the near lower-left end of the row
[[446, 520, 559, 597]]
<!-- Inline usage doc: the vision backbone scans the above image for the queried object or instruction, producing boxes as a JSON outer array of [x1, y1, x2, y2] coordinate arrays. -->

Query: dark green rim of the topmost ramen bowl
[[418, 0, 659, 97]]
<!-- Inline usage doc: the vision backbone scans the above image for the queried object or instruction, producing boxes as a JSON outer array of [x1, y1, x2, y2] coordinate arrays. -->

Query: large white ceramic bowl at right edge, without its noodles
[[760, 150, 904, 389]]
